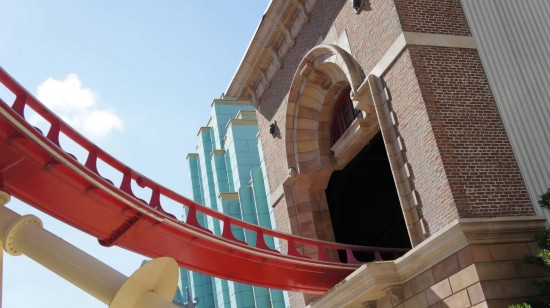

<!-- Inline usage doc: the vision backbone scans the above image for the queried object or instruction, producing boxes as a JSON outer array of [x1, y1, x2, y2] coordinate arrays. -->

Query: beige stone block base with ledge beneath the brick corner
[[311, 217, 546, 307]]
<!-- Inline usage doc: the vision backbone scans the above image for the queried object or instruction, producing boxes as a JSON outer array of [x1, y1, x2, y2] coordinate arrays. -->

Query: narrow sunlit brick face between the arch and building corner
[[383, 51, 458, 233]]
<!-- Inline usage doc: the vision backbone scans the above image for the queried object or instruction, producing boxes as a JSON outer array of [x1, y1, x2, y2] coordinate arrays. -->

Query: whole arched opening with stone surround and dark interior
[[283, 45, 416, 262]]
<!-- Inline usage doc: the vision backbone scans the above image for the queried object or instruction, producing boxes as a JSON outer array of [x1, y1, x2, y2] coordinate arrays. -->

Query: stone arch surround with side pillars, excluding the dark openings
[[283, 45, 420, 255]]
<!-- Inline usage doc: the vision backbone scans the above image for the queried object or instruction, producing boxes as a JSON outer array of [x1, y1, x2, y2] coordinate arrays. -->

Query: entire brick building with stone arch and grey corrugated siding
[[221, 0, 550, 307]]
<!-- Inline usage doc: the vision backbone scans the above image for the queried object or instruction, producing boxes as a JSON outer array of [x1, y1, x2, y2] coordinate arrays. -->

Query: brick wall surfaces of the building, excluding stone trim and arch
[[258, 0, 535, 241]]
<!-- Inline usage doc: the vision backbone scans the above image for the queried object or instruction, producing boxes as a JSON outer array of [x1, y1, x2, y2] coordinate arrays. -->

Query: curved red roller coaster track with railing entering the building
[[0, 68, 407, 294]]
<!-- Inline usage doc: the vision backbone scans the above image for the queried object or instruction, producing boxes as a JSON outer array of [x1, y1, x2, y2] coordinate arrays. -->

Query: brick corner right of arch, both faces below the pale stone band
[[383, 46, 535, 233]]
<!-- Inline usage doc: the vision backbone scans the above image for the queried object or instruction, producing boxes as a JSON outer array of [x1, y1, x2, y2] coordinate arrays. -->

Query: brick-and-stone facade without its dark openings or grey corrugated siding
[[226, 0, 546, 307]]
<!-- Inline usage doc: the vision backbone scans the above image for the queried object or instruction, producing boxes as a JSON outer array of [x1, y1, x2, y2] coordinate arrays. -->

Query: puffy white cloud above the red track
[[35, 74, 124, 138]]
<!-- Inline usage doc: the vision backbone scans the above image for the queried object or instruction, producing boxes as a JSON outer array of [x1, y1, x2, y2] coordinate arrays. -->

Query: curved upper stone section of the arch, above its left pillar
[[286, 45, 362, 173]]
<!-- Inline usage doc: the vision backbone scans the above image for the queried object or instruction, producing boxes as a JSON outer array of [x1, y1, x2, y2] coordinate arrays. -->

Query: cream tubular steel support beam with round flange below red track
[[0, 191, 178, 308]]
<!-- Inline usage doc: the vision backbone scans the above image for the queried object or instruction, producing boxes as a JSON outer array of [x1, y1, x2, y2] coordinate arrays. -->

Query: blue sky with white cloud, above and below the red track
[[0, 0, 269, 308]]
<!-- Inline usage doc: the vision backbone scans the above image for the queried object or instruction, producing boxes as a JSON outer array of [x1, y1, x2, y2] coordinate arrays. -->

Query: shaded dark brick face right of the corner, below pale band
[[409, 46, 535, 217]]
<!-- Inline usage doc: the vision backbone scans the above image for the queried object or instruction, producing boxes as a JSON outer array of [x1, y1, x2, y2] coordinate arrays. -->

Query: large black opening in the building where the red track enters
[[326, 133, 410, 262]]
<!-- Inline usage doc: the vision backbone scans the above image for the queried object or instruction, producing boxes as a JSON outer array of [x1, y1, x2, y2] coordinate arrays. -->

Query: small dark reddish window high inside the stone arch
[[330, 87, 363, 145]]
